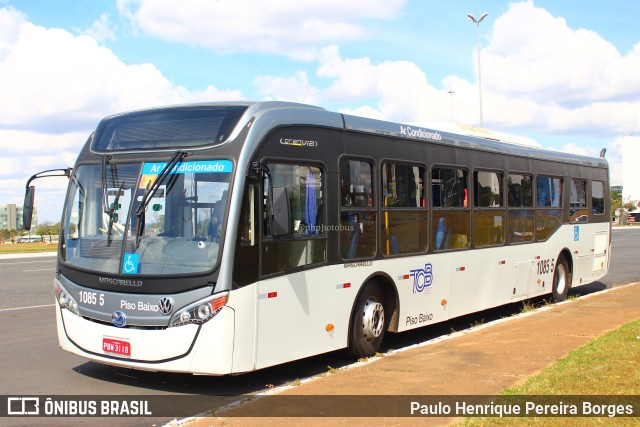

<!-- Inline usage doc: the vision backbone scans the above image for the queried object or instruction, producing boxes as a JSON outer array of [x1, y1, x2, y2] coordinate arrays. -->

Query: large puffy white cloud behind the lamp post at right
[[481, 0, 640, 134]]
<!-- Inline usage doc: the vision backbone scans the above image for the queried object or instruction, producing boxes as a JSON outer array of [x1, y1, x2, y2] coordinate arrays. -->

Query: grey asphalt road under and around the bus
[[0, 227, 640, 426]]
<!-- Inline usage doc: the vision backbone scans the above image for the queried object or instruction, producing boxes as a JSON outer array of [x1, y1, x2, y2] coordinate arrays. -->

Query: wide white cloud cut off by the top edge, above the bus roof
[[117, 0, 405, 58]]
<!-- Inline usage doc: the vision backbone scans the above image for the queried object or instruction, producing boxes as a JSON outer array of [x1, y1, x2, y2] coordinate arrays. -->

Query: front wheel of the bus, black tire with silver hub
[[346, 282, 386, 359]]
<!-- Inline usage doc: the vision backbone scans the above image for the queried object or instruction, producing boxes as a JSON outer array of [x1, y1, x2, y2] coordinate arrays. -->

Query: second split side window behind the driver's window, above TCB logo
[[380, 163, 428, 255]]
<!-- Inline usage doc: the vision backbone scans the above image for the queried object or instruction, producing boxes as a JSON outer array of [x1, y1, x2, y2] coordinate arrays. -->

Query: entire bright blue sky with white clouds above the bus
[[0, 0, 640, 223]]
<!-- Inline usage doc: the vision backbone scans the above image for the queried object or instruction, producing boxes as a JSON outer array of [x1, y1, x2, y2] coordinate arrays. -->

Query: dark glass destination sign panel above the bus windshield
[[91, 106, 246, 152]]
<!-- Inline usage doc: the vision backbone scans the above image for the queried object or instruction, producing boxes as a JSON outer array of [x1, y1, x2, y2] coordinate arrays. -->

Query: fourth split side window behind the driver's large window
[[473, 171, 505, 247]]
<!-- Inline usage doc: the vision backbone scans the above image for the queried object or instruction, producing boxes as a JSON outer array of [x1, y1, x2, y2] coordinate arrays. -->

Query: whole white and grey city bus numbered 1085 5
[[25, 102, 610, 375]]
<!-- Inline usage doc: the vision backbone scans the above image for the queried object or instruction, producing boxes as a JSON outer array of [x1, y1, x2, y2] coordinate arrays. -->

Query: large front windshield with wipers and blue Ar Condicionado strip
[[61, 160, 233, 276]]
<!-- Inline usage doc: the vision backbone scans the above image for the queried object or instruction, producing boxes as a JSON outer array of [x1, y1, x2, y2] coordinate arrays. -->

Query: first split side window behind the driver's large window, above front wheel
[[340, 159, 377, 259]]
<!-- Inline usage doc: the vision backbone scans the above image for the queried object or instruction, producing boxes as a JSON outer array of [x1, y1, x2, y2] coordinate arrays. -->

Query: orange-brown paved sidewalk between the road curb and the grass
[[184, 283, 640, 427]]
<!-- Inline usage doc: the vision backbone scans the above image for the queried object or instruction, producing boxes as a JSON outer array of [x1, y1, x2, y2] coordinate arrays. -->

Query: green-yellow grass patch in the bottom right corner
[[459, 320, 640, 427]]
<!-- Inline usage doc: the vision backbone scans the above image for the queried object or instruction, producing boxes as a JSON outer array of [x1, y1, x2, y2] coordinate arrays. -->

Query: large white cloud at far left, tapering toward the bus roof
[[0, 8, 241, 133]]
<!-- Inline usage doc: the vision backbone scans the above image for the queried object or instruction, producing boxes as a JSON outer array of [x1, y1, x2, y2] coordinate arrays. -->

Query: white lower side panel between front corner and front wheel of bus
[[256, 263, 358, 369]]
